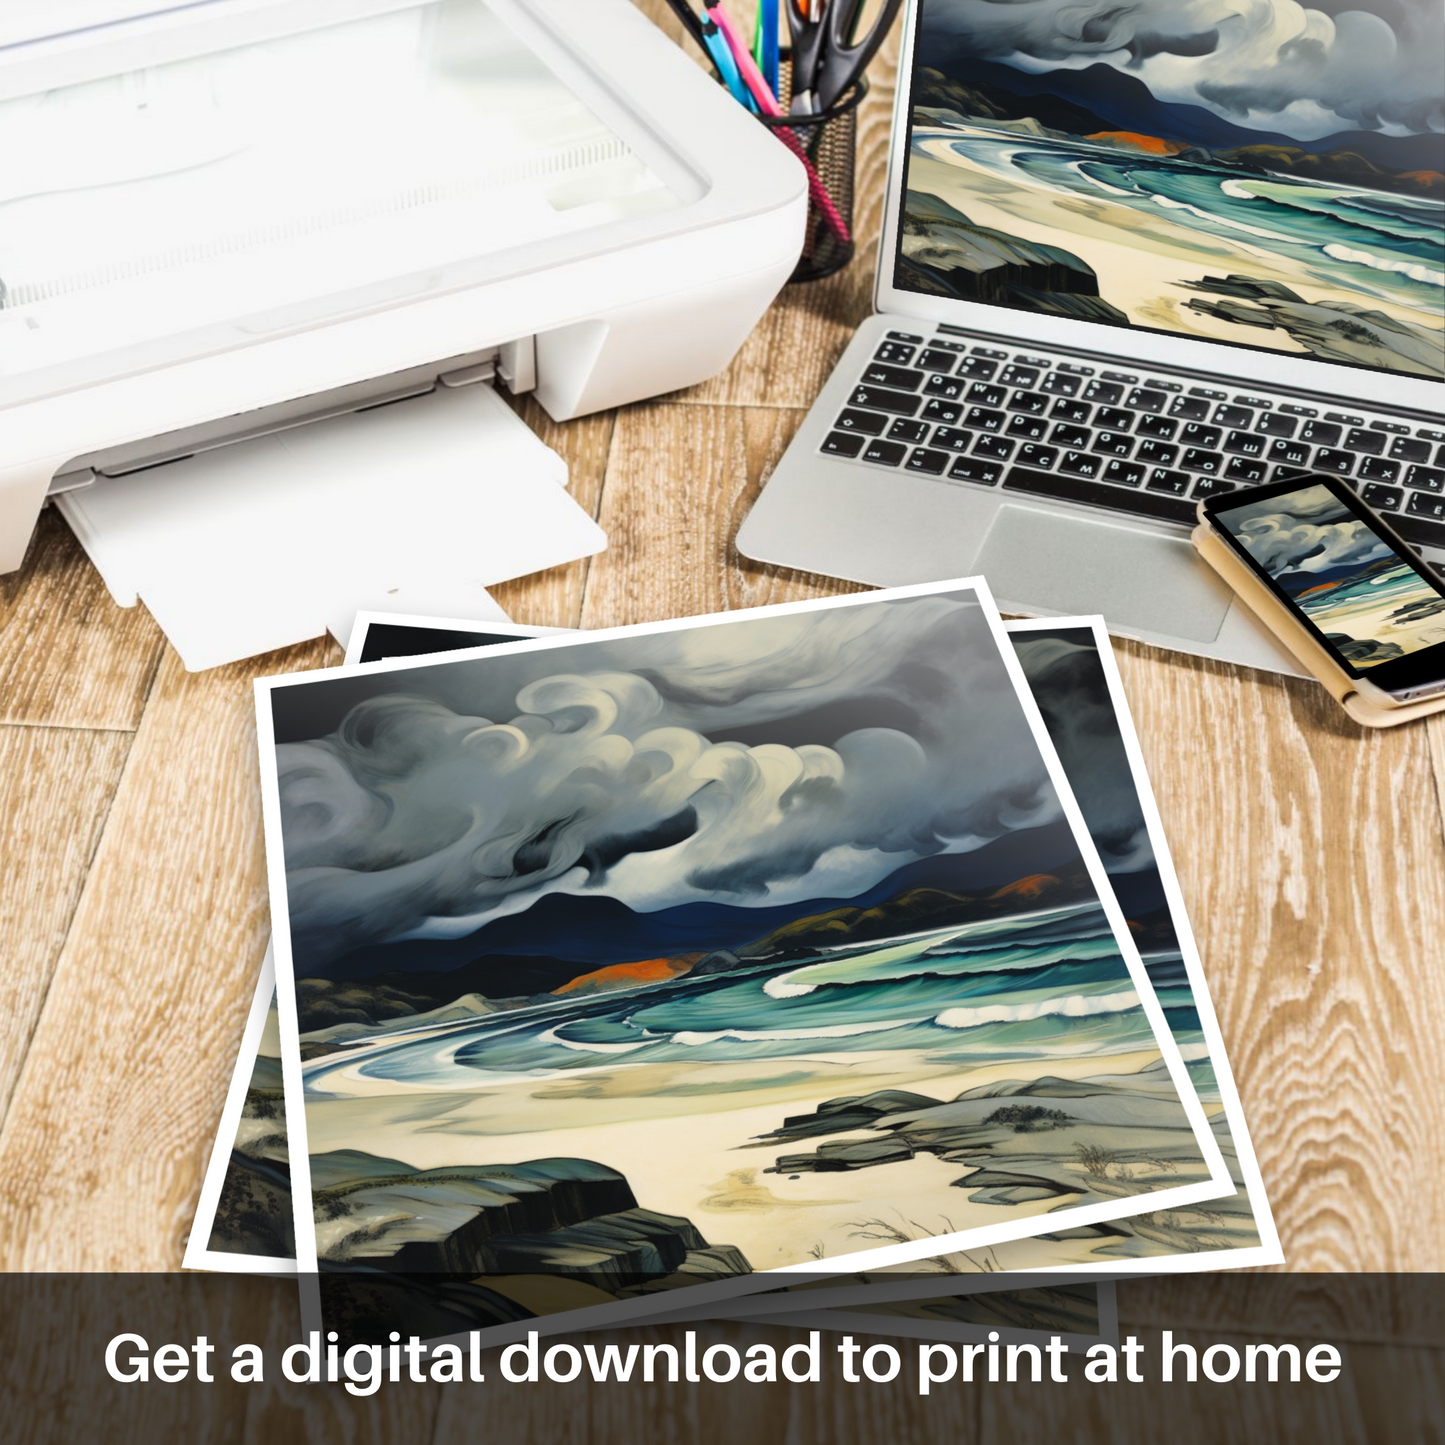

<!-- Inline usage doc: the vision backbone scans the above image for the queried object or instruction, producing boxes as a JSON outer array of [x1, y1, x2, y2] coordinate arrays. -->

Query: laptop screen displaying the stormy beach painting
[[894, 0, 1445, 377]]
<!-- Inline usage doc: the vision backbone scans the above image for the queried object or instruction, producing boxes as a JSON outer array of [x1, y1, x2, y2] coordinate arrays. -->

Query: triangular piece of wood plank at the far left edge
[[0, 727, 131, 1120]]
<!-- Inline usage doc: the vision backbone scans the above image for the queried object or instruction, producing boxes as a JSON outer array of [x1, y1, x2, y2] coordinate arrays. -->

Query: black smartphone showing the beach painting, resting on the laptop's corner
[[1199, 473, 1445, 704]]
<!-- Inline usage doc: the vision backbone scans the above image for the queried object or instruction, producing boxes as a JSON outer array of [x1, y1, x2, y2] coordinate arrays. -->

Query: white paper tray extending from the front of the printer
[[55, 384, 607, 670]]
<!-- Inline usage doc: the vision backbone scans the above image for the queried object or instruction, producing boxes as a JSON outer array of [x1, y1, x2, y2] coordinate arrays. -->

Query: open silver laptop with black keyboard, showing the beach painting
[[737, 0, 1445, 675]]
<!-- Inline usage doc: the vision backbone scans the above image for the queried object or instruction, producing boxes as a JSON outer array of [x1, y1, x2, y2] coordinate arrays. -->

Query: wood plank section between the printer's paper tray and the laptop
[[582, 403, 863, 627]]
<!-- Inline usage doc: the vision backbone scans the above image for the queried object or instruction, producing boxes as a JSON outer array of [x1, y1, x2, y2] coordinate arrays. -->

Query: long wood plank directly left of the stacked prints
[[0, 643, 338, 1270]]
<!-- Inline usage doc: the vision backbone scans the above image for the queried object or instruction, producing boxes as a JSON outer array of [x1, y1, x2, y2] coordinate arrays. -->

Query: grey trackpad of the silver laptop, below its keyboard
[[975, 506, 1233, 642]]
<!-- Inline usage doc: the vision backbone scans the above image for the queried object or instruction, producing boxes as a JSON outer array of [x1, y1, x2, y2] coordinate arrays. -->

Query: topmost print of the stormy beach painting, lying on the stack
[[262, 584, 1227, 1332]]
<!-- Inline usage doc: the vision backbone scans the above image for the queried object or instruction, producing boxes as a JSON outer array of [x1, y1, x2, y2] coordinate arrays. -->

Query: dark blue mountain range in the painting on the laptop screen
[[913, 58, 1445, 194]]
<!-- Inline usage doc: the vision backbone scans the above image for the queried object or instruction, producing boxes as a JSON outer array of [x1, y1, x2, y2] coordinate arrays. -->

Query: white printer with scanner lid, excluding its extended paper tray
[[0, 0, 806, 661]]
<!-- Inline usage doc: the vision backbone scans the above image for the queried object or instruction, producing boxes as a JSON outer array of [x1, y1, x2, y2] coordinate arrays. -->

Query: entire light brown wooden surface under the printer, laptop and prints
[[0, 0, 1445, 1439]]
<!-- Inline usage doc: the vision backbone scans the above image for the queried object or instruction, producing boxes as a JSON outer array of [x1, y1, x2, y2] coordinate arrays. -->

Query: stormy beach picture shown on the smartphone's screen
[[1215, 484, 1445, 668]]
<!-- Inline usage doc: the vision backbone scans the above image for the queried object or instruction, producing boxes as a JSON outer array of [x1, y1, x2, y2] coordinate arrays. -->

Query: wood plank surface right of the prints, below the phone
[[1117, 643, 1445, 1270]]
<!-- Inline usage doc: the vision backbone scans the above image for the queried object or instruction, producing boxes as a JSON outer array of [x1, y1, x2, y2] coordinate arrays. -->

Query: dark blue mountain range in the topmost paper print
[[313, 821, 1078, 1003]]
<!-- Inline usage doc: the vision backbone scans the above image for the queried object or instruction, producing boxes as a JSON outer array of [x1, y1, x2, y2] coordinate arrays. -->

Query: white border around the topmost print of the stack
[[254, 578, 1234, 1342]]
